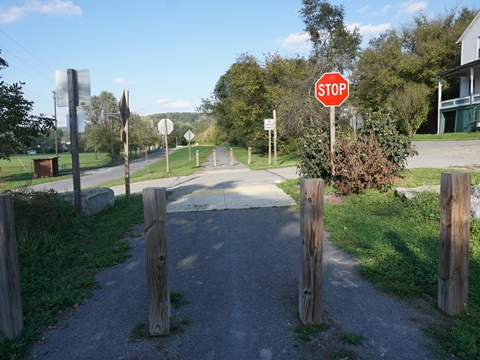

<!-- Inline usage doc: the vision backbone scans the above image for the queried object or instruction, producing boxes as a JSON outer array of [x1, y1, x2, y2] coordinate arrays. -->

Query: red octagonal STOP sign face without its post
[[315, 72, 349, 106]]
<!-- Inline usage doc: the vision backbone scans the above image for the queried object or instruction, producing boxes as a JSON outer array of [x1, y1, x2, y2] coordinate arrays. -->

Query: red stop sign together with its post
[[315, 72, 349, 166]]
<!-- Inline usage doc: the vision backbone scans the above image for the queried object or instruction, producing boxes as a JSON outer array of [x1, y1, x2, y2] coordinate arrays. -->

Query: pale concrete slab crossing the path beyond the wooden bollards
[[167, 184, 295, 213]]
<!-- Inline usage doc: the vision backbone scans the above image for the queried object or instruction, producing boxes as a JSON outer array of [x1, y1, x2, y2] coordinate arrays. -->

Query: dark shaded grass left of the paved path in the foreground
[[0, 193, 143, 359]]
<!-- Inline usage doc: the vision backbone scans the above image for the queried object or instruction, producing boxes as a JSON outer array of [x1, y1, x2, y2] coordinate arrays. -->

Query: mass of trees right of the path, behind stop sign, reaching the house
[[199, 0, 476, 151]]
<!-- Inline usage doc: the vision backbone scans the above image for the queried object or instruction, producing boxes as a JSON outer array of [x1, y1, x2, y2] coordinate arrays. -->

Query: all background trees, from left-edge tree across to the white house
[[0, 0, 476, 161]]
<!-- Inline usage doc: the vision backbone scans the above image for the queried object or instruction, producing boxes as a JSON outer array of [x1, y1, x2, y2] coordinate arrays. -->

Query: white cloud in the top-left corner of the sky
[[0, 0, 82, 24]]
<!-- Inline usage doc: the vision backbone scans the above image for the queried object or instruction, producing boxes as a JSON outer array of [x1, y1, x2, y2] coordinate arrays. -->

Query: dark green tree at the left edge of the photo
[[0, 51, 54, 160]]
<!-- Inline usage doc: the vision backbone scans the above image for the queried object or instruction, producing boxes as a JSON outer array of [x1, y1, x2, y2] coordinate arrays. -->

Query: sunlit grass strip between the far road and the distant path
[[98, 146, 215, 187]]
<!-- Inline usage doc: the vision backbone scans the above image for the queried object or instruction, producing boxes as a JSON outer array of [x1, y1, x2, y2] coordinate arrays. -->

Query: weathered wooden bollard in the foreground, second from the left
[[143, 188, 170, 336]]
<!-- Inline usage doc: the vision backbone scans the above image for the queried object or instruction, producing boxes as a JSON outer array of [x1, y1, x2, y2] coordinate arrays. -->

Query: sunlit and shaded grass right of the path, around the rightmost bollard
[[279, 169, 480, 359]]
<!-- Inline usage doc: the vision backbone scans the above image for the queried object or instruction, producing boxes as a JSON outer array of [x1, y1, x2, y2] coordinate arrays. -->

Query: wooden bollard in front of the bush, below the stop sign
[[299, 179, 324, 325]]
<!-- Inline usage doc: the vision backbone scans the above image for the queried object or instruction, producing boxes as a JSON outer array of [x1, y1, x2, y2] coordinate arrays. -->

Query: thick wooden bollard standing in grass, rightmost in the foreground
[[438, 173, 471, 315]]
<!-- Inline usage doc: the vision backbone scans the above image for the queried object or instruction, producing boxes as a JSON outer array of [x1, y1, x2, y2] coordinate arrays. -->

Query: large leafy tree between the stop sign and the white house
[[352, 8, 476, 132]]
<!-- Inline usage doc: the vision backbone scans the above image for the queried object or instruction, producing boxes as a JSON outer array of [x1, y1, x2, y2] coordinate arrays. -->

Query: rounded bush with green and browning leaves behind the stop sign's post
[[298, 112, 416, 194]]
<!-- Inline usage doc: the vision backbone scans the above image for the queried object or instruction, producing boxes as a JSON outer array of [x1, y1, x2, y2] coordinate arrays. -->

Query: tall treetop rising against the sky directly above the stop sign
[[300, 0, 362, 73]]
